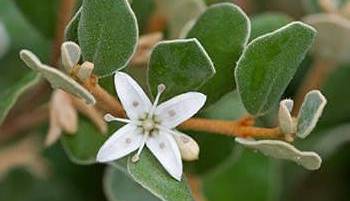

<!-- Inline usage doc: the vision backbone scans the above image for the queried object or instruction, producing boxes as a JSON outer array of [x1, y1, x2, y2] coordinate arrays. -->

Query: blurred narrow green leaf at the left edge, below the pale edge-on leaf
[[0, 73, 40, 125]]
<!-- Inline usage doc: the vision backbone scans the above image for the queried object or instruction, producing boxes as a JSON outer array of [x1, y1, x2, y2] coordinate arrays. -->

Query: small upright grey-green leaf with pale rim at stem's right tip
[[297, 90, 327, 138]]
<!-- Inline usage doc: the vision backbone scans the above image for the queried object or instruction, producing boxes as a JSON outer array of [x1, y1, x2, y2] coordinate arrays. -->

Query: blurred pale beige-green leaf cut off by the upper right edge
[[304, 14, 350, 63]]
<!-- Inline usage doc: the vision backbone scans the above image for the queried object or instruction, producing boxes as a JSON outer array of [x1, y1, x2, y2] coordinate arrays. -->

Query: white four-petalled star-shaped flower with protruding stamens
[[97, 72, 206, 181]]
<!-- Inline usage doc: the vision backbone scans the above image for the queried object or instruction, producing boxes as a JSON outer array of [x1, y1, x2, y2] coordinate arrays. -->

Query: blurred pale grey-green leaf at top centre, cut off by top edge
[[156, 0, 206, 38]]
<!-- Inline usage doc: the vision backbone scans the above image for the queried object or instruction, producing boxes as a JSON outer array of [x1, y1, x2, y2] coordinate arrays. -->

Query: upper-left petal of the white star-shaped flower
[[114, 72, 152, 119]]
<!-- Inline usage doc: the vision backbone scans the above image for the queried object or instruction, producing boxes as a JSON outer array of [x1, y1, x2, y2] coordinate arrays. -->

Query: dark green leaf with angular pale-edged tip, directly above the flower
[[148, 39, 215, 100]]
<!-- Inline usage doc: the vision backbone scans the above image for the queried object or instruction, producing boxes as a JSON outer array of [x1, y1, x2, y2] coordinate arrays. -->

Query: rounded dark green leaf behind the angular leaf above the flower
[[186, 3, 250, 103]]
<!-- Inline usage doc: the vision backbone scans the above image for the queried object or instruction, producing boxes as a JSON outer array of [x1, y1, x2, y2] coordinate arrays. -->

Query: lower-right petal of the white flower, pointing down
[[146, 131, 182, 181]]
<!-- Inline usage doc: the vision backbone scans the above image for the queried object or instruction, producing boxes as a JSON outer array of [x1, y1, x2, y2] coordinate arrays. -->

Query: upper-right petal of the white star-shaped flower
[[155, 92, 206, 128]]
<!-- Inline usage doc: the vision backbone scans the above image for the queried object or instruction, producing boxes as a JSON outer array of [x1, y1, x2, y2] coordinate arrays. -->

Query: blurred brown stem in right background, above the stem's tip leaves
[[293, 57, 336, 116]]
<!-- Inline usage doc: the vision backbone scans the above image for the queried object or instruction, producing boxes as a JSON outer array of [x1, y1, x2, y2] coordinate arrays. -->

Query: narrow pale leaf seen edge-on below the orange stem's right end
[[236, 138, 322, 170]]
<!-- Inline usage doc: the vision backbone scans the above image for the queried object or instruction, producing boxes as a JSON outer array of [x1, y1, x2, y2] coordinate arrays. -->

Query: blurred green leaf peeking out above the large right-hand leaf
[[250, 12, 292, 40]]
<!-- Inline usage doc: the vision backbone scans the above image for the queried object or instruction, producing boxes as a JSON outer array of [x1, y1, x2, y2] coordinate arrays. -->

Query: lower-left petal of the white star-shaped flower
[[96, 124, 142, 162]]
